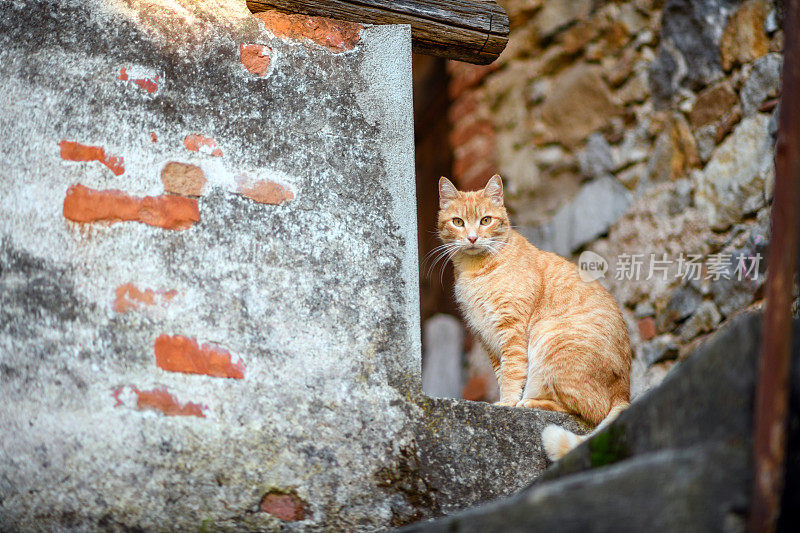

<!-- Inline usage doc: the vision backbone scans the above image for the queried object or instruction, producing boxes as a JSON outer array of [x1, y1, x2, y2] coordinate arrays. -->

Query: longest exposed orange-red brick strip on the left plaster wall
[[63, 184, 200, 230]]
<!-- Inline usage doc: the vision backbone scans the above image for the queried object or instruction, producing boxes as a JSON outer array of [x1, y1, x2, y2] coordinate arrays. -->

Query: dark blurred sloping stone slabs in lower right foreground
[[402, 313, 780, 532]]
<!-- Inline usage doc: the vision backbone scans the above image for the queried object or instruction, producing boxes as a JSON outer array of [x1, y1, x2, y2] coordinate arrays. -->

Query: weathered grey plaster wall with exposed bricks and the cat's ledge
[[0, 0, 588, 530]]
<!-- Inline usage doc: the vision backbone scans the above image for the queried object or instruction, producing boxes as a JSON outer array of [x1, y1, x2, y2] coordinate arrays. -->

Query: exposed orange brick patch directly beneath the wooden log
[[255, 11, 363, 53]]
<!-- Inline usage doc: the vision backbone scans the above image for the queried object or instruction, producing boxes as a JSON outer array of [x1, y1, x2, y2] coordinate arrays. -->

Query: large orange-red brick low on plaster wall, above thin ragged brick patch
[[154, 335, 244, 379]]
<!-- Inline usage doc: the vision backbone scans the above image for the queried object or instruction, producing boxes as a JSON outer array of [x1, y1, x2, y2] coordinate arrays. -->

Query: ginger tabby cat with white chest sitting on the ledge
[[438, 175, 631, 460]]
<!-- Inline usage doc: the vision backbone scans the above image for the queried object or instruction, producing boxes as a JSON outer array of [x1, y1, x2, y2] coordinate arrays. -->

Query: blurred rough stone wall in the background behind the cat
[[440, 0, 783, 400]]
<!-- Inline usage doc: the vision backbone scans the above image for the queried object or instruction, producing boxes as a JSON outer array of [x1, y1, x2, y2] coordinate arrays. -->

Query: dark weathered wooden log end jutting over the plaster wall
[[247, 0, 509, 65]]
